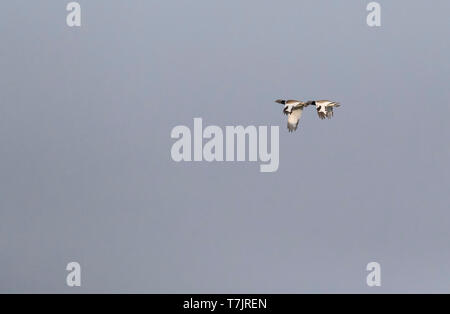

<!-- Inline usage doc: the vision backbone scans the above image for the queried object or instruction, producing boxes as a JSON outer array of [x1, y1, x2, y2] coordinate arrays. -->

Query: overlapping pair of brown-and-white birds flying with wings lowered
[[275, 99, 340, 132]]
